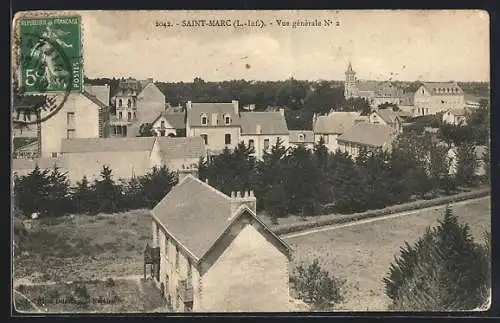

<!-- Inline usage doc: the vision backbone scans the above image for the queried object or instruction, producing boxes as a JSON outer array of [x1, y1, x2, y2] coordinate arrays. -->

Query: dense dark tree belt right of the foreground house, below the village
[[199, 134, 486, 223]]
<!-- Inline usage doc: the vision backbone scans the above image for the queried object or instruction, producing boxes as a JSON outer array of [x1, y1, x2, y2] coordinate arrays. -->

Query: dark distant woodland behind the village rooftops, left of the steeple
[[86, 78, 369, 129]]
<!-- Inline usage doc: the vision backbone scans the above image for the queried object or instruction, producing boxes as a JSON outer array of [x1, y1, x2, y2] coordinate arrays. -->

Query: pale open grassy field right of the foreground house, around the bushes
[[287, 198, 491, 311]]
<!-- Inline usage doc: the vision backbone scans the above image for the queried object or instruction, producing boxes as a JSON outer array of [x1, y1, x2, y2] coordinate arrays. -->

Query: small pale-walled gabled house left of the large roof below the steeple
[[313, 111, 363, 152]]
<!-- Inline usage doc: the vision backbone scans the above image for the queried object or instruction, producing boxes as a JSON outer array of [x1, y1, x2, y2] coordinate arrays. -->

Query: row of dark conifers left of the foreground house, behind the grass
[[14, 166, 178, 216]]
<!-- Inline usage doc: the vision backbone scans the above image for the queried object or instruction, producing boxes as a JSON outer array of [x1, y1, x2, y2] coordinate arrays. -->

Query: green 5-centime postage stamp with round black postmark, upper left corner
[[13, 16, 83, 124]]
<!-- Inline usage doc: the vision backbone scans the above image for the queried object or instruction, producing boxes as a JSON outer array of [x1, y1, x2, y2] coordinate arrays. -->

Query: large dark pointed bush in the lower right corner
[[383, 208, 490, 311]]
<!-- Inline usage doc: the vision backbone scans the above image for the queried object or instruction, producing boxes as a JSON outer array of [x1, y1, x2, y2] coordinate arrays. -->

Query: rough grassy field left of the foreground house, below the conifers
[[14, 210, 151, 282]]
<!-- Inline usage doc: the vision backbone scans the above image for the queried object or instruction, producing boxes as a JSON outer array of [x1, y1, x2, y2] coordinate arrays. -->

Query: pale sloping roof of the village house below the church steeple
[[337, 123, 396, 147]]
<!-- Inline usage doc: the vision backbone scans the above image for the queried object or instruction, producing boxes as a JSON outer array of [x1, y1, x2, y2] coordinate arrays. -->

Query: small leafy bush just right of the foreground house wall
[[291, 259, 345, 310]]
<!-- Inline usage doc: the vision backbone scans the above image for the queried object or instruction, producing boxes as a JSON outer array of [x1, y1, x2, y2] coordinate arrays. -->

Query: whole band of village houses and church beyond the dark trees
[[13, 68, 488, 184]]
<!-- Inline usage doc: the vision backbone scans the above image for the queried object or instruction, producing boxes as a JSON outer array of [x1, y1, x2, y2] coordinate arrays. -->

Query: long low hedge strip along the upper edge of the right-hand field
[[273, 188, 490, 235]]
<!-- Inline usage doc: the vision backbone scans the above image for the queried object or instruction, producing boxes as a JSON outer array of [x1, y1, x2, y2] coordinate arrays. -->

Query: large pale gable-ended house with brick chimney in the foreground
[[145, 174, 291, 312]]
